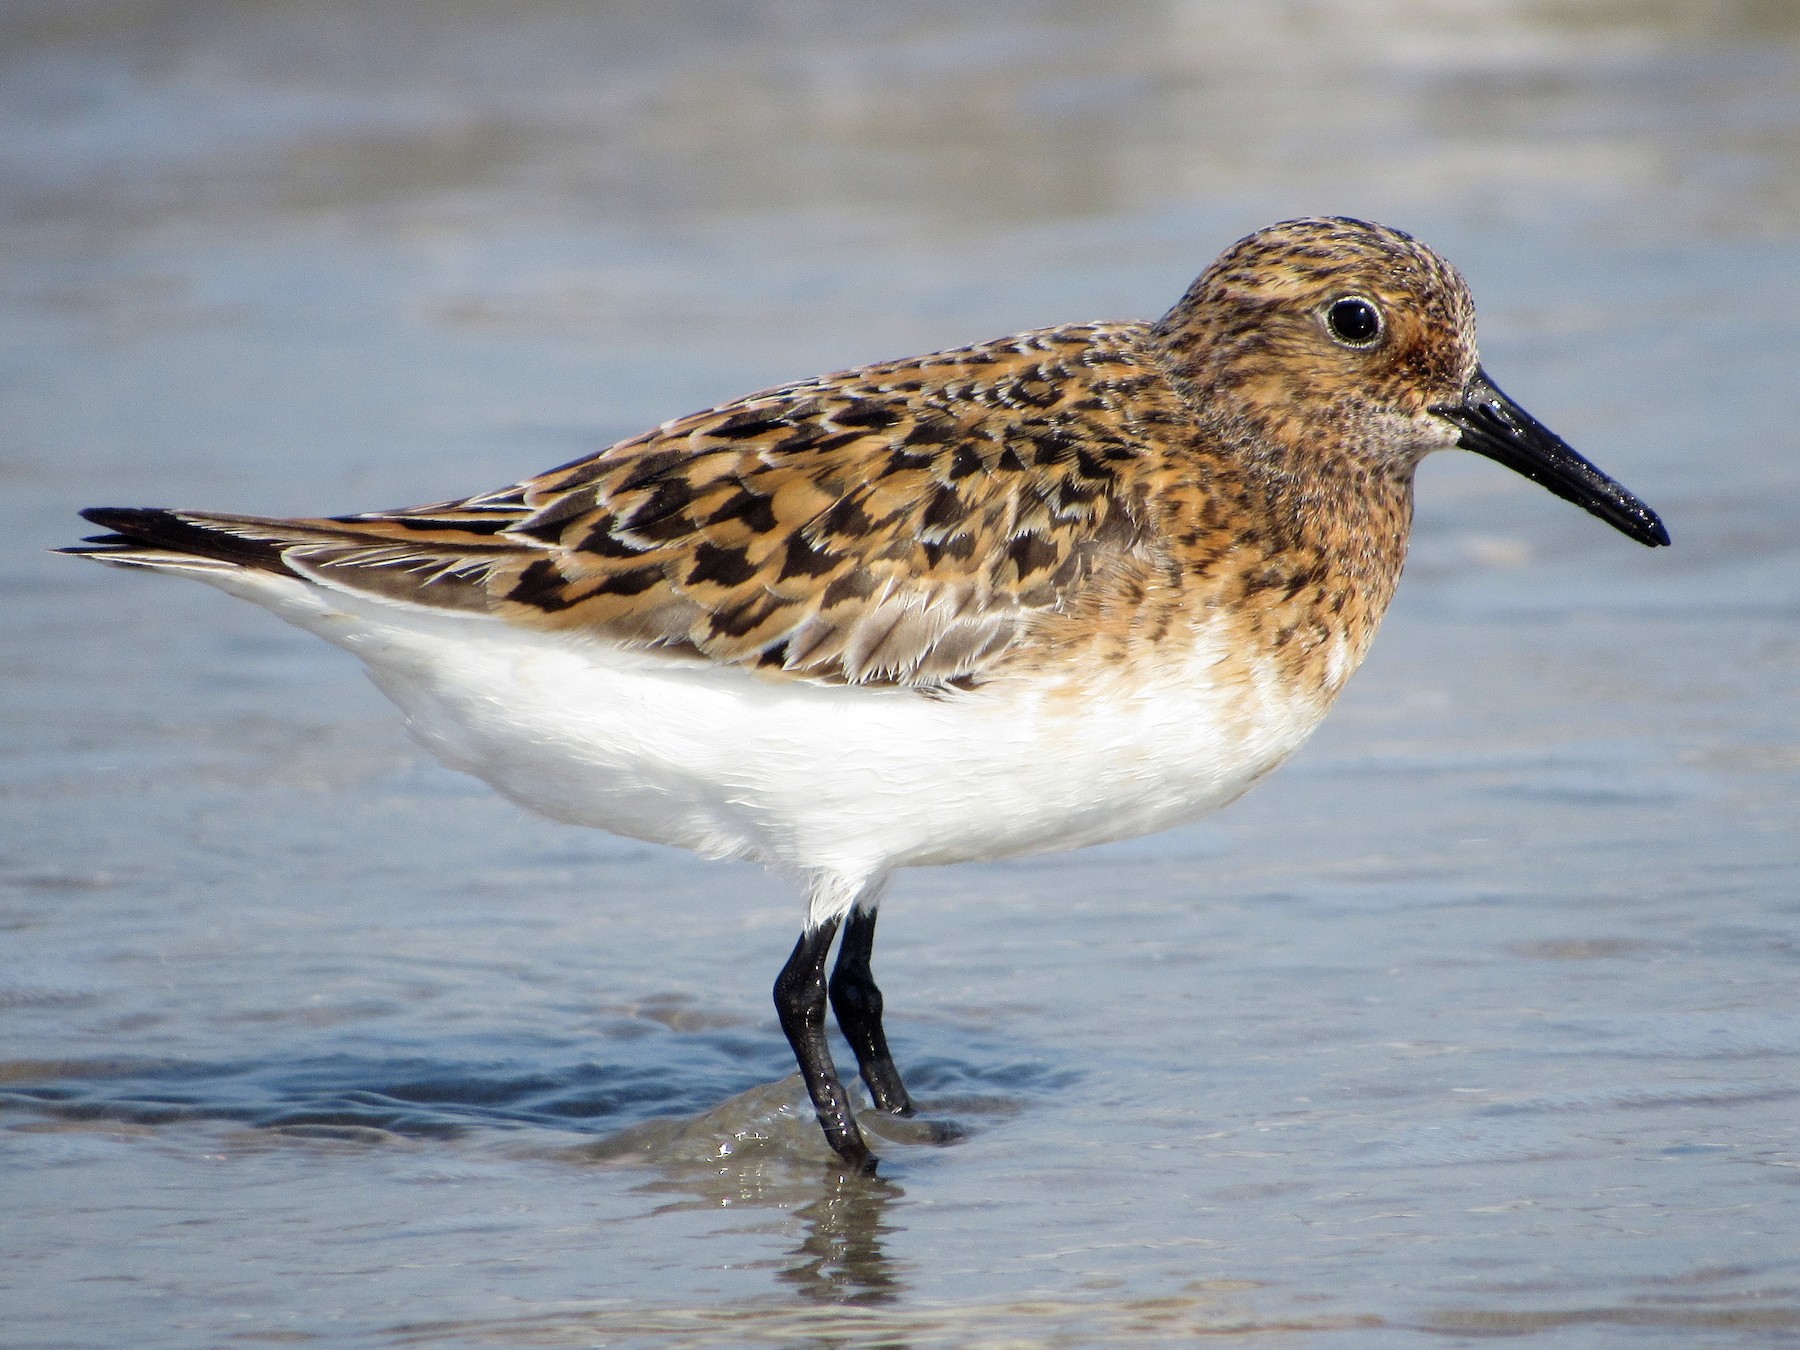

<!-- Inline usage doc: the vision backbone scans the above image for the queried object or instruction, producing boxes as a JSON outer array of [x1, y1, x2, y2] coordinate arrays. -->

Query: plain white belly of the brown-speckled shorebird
[[197, 574, 1325, 900]]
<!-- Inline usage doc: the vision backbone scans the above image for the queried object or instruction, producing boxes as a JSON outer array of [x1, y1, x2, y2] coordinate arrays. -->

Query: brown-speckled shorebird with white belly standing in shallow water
[[68, 218, 1669, 1172]]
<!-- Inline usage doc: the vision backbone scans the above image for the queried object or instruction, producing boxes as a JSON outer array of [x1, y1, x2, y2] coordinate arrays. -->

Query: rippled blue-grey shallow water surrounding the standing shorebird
[[0, 0, 1800, 1346]]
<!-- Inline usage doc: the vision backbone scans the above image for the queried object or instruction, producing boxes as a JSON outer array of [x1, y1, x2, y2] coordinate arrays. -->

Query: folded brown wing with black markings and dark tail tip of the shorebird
[[73, 326, 1161, 686]]
